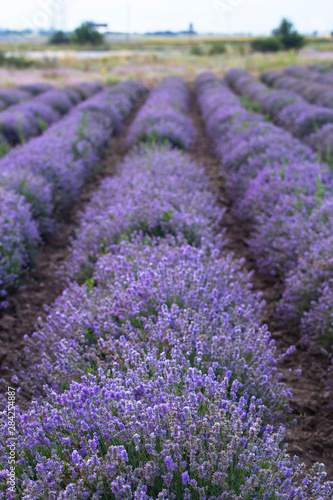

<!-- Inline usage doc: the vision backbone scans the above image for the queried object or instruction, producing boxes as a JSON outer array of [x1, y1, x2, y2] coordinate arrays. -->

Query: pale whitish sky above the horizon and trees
[[0, 0, 333, 34]]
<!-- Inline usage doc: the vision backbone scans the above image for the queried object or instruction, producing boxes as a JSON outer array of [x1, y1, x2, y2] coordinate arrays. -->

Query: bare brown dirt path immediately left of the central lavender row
[[0, 107, 140, 392]]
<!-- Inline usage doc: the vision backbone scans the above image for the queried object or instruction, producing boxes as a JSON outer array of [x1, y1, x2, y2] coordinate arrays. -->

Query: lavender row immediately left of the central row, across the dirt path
[[0, 82, 146, 305]]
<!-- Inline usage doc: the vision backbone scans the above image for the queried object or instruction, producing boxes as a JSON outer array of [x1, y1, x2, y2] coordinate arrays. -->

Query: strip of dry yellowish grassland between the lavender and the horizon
[[0, 35, 333, 87]]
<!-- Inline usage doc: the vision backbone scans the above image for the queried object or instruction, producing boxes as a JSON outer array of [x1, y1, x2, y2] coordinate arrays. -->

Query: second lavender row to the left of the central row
[[0, 83, 103, 156]]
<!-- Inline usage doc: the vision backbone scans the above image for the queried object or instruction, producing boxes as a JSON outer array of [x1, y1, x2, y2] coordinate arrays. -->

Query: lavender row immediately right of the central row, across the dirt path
[[198, 75, 333, 348]]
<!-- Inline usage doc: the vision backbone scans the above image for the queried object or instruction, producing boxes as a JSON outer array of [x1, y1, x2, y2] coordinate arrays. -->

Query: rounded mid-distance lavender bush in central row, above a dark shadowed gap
[[69, 148, 220, 276]]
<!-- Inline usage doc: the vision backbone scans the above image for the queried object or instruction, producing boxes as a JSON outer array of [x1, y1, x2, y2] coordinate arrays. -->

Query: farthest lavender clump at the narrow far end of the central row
[[128, 76, 195, 149]]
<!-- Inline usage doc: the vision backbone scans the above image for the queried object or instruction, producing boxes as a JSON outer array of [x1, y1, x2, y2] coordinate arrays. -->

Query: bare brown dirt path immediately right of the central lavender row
[[191, 91, 333, 480]]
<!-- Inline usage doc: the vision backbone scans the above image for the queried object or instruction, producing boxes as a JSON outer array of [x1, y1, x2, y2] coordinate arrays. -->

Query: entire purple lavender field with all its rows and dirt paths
[[0, 65, 333, 500]]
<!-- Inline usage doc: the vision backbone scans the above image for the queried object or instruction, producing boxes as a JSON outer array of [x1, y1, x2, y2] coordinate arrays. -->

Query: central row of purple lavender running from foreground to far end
[[0, 79, 332, 500]]
